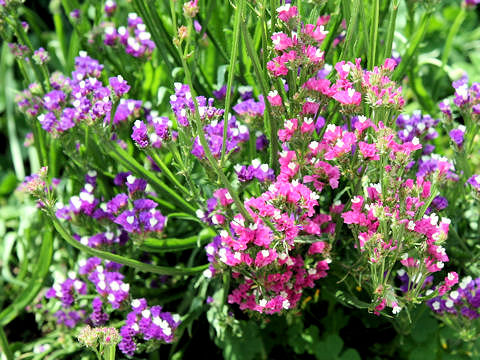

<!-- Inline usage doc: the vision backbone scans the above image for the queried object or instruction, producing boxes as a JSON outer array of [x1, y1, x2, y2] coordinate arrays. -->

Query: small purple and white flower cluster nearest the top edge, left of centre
[[103, 12, 155, 58]]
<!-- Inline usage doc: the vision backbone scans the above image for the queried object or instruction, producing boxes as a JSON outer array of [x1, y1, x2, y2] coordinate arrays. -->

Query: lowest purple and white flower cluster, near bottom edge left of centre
[[118, 298, 180, 356]]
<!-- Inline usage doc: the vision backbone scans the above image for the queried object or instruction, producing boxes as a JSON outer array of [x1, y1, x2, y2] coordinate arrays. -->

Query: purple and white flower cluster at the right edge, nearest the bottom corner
[[427, 276, 480, 320]]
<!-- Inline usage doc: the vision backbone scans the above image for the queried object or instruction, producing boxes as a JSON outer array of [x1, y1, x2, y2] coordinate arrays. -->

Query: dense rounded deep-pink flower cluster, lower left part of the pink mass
[[204, 181, 330, 314]]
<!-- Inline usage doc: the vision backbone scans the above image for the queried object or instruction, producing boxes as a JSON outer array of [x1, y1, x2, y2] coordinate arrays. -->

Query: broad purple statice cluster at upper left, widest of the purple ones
[[17, 51, 141, 136]]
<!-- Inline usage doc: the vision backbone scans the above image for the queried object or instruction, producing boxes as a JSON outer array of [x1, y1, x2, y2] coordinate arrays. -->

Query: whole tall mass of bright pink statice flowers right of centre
[[197, 6, 455, 314]]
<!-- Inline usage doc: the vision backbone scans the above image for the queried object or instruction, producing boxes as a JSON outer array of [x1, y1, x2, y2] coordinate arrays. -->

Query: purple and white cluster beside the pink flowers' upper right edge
[[396, 111, 440, 143]]
